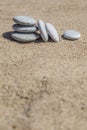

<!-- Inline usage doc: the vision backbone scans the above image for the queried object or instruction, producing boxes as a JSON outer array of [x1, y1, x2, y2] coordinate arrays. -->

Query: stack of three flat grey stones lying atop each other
[[11, 16, 40, 42]]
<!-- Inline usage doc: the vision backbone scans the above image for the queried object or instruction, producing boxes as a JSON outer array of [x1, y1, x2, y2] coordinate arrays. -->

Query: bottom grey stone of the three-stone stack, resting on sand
[[11, 32, 40, 42]]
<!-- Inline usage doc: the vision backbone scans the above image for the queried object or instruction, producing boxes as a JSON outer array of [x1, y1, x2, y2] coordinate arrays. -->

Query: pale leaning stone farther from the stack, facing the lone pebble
[[46, 23, 59, 42]]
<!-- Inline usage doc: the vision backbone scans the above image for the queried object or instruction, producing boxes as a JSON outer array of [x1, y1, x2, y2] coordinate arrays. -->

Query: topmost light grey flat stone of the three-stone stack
[[13, 16, 37, 26]]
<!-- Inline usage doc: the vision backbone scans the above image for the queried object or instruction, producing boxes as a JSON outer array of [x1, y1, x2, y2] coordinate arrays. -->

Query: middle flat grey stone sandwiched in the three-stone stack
[[12, 24, 38, 33]]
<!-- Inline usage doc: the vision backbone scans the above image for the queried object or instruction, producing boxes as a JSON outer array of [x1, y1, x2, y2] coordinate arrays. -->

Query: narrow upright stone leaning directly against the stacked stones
[[38, 20, 48, 42]]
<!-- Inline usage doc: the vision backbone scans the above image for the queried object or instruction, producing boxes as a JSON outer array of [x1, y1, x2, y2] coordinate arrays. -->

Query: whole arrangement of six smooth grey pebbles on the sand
[[11, 16, 81, 42]]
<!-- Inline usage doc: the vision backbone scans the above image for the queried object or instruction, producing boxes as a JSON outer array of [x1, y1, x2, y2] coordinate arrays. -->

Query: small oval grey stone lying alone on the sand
[[63, 30, 81, 40]]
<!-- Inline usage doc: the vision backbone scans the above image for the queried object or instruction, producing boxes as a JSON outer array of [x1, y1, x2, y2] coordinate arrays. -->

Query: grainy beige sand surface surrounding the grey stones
[[0, 0, 87, 130]]
